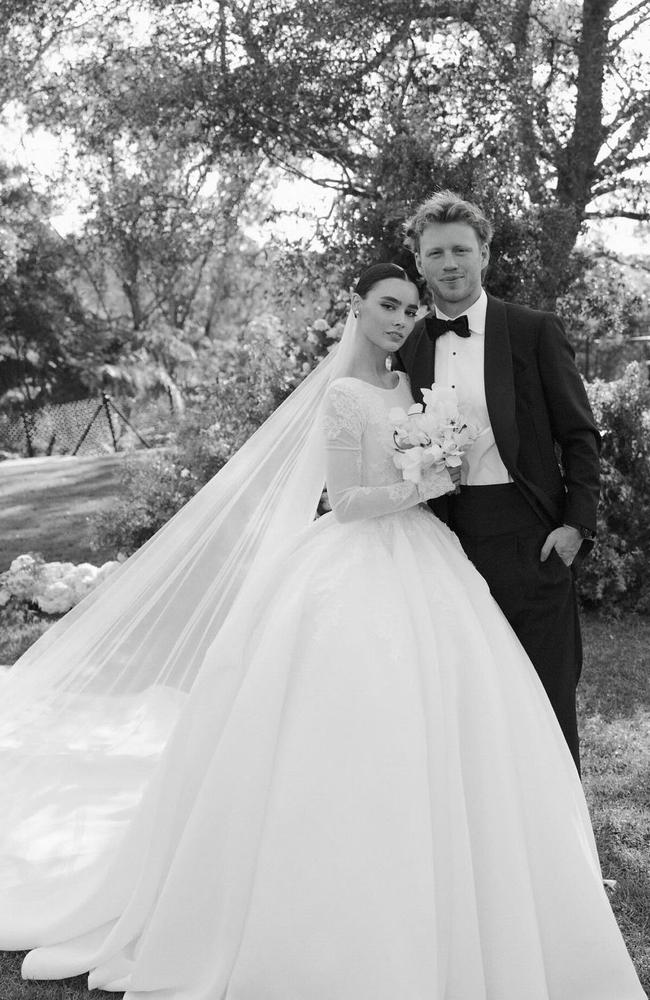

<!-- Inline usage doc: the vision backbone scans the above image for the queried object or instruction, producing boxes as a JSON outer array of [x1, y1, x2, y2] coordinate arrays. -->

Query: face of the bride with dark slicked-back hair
[[354, 278, 420, 353]]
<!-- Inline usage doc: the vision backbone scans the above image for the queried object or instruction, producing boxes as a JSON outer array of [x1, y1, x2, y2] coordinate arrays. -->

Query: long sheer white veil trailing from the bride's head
[[0, 313, 355, 948]]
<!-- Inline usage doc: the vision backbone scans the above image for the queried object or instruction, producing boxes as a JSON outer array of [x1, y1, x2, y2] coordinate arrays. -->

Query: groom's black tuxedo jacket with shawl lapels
[[395, 295, 600, 551]]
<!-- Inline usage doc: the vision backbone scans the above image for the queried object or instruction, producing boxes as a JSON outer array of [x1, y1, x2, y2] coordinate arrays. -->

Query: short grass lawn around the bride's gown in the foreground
[[0, 613, 650, 1000]]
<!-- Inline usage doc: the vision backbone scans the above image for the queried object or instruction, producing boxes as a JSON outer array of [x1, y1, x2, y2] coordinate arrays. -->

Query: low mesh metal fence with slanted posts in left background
[[0, 393, 149, 457]]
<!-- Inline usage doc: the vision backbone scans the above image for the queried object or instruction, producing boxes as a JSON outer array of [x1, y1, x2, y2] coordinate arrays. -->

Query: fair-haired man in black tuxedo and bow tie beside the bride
[[395, 191, 599, 770]]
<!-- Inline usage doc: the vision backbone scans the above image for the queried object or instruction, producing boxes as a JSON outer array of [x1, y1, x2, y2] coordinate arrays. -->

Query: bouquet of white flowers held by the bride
[[388, 382, 478, 483]]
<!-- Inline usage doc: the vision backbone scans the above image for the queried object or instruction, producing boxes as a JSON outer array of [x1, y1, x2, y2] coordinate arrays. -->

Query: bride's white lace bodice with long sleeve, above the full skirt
[[323, 372, 453, 521]]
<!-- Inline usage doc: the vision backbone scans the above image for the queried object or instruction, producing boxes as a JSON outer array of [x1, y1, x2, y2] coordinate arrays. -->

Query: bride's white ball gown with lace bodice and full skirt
[[0, 375, 644, 1000]]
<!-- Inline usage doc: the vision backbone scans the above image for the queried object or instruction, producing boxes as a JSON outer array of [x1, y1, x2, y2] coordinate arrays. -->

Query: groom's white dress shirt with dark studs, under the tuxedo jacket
[[435, 290, 512, 486]]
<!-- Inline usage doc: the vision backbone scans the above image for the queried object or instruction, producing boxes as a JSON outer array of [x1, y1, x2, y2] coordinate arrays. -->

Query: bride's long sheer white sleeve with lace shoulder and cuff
[[323, 385, 453, 522]]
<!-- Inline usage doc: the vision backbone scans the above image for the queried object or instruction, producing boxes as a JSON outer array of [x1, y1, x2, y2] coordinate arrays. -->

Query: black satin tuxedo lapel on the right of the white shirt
[[484, 295, 519, 474]]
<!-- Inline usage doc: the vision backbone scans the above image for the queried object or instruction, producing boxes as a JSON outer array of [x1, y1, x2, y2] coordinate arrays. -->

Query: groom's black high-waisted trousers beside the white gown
[[442, 483, 582, 771]]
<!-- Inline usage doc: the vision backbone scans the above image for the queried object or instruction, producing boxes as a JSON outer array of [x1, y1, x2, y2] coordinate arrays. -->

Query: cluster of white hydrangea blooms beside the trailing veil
[[0, 555, 123, 615]]
